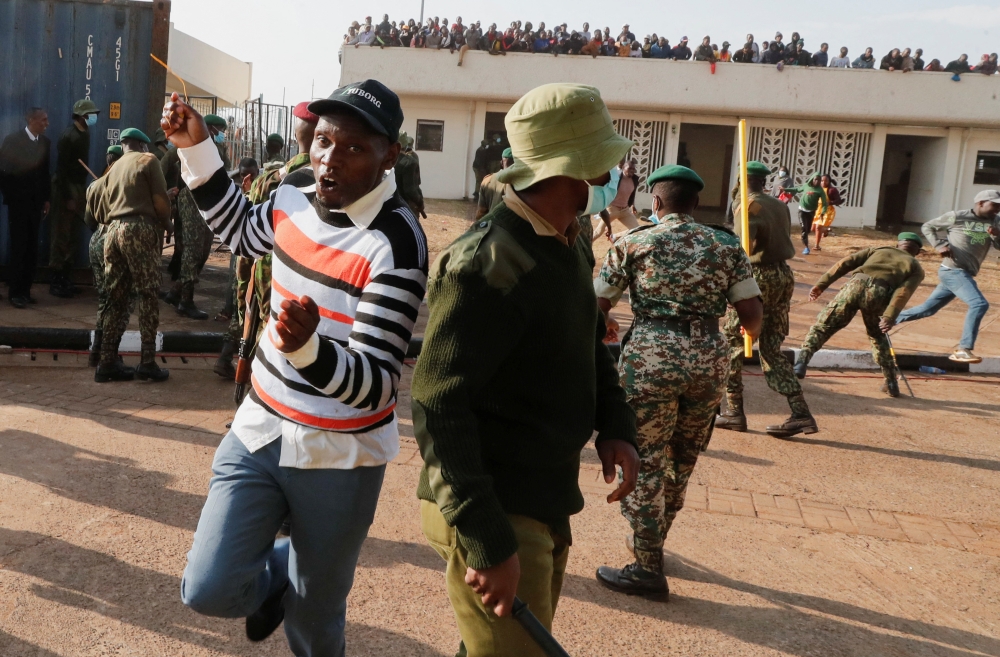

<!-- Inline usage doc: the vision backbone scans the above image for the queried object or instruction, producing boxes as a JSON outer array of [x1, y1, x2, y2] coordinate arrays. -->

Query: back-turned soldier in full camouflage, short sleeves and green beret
[[594, 165, 763, 599]]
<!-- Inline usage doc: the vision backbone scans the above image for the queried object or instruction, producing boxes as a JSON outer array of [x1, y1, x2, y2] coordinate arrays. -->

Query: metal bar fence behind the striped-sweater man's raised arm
[[167, 94, 299, 167]]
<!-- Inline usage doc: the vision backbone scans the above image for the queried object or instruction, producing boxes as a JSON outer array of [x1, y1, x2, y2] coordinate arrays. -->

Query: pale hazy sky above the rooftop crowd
[[171, 0, 1000, 105]]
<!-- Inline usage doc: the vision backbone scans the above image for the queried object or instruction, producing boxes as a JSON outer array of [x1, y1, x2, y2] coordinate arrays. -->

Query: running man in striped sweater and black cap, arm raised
[[161, 80, 427, 656]]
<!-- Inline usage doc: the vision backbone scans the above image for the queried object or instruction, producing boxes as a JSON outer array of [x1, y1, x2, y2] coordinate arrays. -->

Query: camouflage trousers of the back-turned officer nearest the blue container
[[104, 217, 161, 349]]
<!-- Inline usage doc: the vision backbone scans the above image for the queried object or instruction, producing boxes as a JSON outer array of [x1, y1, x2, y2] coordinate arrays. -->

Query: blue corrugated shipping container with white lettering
[[0, 0, 170, 274]]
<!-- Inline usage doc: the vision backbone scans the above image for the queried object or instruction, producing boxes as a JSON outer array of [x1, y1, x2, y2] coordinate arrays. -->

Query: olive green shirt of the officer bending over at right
[[816, 246, 924, 319]]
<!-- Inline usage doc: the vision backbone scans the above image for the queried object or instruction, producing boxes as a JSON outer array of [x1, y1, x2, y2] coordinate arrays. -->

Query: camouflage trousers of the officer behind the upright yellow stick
[[724, 262, 802, 398]]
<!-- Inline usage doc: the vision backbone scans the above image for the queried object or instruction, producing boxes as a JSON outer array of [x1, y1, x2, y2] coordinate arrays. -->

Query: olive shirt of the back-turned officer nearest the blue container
[[104, 153, 170, 230]]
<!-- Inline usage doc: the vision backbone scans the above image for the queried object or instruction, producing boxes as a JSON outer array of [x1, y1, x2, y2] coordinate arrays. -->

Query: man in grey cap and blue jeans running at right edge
[[896, 189, 1000, 363]]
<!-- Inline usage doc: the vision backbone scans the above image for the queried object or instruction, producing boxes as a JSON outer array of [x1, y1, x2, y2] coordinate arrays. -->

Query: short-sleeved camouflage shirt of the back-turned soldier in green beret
[[594, 214, 760, 320]]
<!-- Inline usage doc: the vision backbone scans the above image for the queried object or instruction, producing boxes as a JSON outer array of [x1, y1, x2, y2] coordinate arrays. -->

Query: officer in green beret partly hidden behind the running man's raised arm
[[160, 114, 232, 319]]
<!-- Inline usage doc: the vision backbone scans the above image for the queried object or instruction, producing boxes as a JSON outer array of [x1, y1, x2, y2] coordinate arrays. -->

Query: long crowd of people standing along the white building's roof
[[344, 14, 997, 75]]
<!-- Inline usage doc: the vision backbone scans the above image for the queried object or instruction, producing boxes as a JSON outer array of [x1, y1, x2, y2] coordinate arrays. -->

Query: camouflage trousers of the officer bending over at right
[[799, 276, 896, 380]]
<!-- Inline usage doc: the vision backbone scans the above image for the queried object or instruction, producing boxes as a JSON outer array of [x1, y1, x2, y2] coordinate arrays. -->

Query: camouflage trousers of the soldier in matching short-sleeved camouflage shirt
[[618, 323, 728, 572]]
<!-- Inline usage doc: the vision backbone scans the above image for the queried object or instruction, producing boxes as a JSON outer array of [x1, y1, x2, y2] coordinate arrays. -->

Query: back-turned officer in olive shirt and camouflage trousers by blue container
[[94, 128, 173, 383]]
